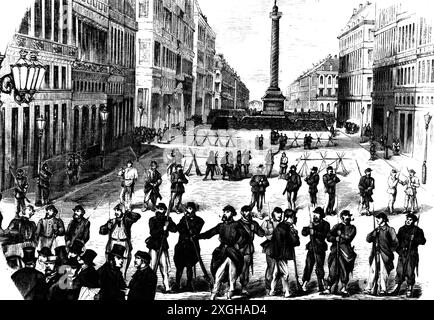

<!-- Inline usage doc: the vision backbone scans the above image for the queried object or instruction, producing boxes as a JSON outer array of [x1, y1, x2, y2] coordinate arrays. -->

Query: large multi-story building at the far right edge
[[372, 2, 434, 159]]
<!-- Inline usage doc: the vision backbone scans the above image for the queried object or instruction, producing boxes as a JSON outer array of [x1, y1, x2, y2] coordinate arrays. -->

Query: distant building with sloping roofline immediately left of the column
[[212, 54, 250, 109]]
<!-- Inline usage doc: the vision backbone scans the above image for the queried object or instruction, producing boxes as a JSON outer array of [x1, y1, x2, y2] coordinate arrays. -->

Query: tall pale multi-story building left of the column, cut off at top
[[135, 0, 195, 128]]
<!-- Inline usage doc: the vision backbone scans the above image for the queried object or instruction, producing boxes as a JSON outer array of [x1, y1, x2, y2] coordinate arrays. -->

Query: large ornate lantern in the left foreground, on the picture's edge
[[0, 50, 46, 105]]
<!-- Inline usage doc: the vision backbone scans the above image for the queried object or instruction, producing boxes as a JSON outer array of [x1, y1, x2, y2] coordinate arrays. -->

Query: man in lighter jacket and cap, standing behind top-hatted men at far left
[[35, 205, 65, 249]]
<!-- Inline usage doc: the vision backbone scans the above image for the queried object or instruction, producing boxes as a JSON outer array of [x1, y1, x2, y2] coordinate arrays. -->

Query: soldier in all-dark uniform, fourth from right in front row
[[301, 207, 330, 291]]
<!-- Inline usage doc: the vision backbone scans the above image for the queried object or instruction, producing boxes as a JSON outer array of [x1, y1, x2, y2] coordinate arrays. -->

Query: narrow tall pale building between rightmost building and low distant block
[[337, 2, 375, 125]]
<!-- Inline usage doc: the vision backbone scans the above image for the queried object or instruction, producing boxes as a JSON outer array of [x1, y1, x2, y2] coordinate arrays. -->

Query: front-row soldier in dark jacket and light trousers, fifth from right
[[269, 209, 300, 298]]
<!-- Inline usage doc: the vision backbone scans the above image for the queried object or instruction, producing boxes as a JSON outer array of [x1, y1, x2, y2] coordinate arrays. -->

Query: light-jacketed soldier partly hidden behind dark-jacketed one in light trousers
[[261, 207, 283, 291]]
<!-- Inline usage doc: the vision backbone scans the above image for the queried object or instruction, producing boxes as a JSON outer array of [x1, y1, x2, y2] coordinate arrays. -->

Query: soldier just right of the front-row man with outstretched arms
[[238, 205, 265, 295]]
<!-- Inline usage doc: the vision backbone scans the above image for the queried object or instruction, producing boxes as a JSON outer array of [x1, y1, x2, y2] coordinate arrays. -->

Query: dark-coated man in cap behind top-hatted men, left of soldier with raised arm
[[65, 205, 90, 249]]
